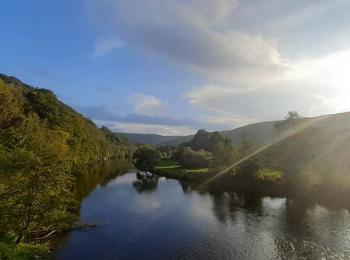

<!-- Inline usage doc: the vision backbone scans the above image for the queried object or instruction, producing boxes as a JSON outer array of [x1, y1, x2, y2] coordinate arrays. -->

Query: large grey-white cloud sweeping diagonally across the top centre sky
[[90, 0, 288, 84]]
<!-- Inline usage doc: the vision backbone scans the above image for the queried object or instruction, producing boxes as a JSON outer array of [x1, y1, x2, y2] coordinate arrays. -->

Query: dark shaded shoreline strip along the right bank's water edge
[[153, 170, 350, 209]]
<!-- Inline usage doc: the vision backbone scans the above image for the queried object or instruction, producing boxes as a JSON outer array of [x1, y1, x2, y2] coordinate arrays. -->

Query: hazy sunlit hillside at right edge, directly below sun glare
[[262, 112, 350, 178]]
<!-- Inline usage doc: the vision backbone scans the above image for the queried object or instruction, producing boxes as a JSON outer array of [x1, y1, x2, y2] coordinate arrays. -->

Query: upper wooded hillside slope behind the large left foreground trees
[[0, 74, 129, 165]]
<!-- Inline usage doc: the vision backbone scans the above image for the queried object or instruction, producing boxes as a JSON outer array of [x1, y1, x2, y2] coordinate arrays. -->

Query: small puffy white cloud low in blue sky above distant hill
[[129, 93, 164, 115]]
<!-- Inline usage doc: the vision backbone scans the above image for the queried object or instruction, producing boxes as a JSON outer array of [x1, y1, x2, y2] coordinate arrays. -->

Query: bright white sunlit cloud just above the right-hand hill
[[184, 49, 350, 123]]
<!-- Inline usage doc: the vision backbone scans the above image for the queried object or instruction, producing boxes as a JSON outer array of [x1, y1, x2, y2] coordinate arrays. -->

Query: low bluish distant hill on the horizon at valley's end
[[117, 133, 193, 146]]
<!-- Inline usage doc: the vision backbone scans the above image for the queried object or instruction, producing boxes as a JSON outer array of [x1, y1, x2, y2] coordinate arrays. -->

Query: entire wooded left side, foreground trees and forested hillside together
[[0, 75, 132, 258]]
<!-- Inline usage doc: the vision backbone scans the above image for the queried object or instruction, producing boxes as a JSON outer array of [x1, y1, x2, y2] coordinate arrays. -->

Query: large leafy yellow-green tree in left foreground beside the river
[[0, 81, 75, 243]]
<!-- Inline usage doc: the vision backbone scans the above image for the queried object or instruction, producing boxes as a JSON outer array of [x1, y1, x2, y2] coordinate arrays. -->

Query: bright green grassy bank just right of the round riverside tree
[[154, 160, 210, 183]]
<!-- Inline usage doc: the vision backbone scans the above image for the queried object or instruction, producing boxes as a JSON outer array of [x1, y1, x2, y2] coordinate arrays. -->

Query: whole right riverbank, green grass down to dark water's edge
[[153, 160, 350, 208]]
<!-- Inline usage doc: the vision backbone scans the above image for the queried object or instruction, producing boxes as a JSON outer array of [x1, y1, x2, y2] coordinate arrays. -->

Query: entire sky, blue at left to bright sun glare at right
[[0, 0, 350, 135]]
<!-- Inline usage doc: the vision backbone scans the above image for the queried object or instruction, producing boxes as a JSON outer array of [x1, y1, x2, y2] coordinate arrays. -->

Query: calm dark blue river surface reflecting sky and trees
[[55, 172, 350, 259]]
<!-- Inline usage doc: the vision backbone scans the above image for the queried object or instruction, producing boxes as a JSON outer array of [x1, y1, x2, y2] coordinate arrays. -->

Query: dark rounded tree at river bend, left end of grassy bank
[[133, 145, 160, 172]]
